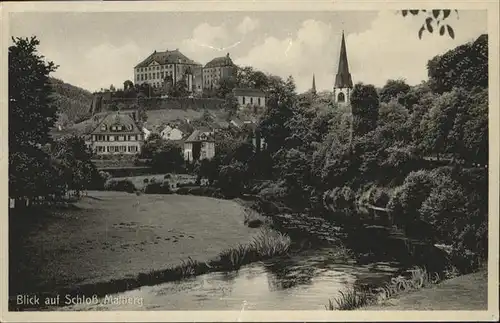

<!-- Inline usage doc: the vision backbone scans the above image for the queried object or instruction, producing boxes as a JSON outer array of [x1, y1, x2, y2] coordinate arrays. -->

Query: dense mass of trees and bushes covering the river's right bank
[[198, 36, 488, 264]]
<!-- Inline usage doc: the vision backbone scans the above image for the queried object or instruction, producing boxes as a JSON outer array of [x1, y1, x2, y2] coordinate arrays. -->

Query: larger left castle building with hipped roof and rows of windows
[[134, 49, 202, 91]]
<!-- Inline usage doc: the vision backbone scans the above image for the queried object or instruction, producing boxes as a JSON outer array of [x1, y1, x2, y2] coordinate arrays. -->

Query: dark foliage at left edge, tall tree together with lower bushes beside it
[[9, 37, 102, 206]]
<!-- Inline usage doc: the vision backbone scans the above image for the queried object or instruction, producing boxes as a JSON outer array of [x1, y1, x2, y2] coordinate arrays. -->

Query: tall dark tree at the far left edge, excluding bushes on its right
[[8, 37, 61, 205]]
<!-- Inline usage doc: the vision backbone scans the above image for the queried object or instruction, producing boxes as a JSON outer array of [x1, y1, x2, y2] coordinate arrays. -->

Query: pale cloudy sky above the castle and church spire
[[9, 10, 487, 92]]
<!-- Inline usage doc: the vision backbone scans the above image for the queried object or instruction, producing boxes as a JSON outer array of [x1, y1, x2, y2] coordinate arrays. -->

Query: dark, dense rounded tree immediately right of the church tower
[[350, 83, 379, 136]]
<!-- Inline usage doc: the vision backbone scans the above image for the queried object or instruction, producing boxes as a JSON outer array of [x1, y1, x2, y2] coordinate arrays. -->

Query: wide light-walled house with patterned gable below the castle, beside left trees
[[89, 112, 144, 155]]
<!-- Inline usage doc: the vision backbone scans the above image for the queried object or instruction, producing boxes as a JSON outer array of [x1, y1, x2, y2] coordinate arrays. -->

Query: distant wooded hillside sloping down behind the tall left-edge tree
[[49, 77, 93, 126]]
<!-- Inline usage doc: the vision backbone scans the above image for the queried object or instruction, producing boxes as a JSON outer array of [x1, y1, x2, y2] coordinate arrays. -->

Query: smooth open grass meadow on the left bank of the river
[[9, 192, 256, 295]]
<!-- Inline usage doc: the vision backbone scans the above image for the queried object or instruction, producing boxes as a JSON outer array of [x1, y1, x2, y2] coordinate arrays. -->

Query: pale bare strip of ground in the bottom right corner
[[360, 271, 488, 311]]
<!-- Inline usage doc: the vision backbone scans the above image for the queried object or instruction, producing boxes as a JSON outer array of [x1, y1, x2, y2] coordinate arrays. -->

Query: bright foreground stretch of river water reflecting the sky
[[63, 249, 398, 310]]
